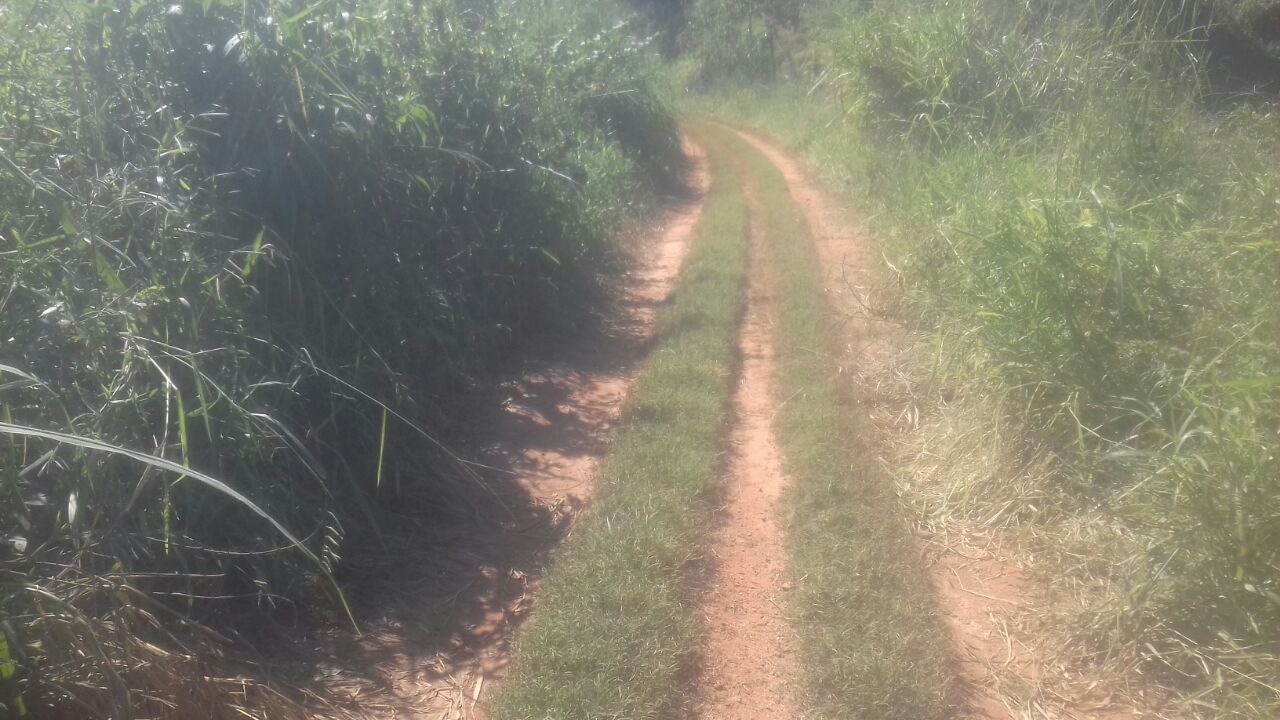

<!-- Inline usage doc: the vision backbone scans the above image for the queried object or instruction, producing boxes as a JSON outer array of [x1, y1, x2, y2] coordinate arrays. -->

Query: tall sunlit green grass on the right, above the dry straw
[[788, 0, 1280, 716]]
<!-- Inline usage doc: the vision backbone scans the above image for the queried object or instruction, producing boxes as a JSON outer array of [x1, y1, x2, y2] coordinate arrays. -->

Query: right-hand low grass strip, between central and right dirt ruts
[[724, 124, 959, 720]]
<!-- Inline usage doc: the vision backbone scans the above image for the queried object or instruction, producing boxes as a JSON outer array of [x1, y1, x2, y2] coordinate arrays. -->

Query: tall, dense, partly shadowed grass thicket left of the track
[[0, 0, 680, 717]]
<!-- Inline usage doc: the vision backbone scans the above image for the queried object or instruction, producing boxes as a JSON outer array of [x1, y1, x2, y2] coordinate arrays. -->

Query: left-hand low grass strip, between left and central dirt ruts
[[493, 120, 746, 720]]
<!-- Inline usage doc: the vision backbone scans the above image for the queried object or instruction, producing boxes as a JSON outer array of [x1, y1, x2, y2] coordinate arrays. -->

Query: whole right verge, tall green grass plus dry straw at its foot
[[677, 0, 1280, 717]]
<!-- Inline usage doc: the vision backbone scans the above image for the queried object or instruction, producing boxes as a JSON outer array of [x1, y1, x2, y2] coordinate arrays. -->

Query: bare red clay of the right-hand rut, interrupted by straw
[[739, 132, 1152, 720]]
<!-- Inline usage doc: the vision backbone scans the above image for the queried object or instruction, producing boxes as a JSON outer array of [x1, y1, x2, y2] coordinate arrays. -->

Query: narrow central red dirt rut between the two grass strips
[[696, 175, 800, 720]]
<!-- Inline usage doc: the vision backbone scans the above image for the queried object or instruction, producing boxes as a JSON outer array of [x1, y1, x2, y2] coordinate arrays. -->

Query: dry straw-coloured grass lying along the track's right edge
[[852, 348, 1197, 719]]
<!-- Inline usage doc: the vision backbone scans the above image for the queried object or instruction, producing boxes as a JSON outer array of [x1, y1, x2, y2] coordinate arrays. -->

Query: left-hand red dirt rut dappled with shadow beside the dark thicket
[[320, 143, 710, 720]]
